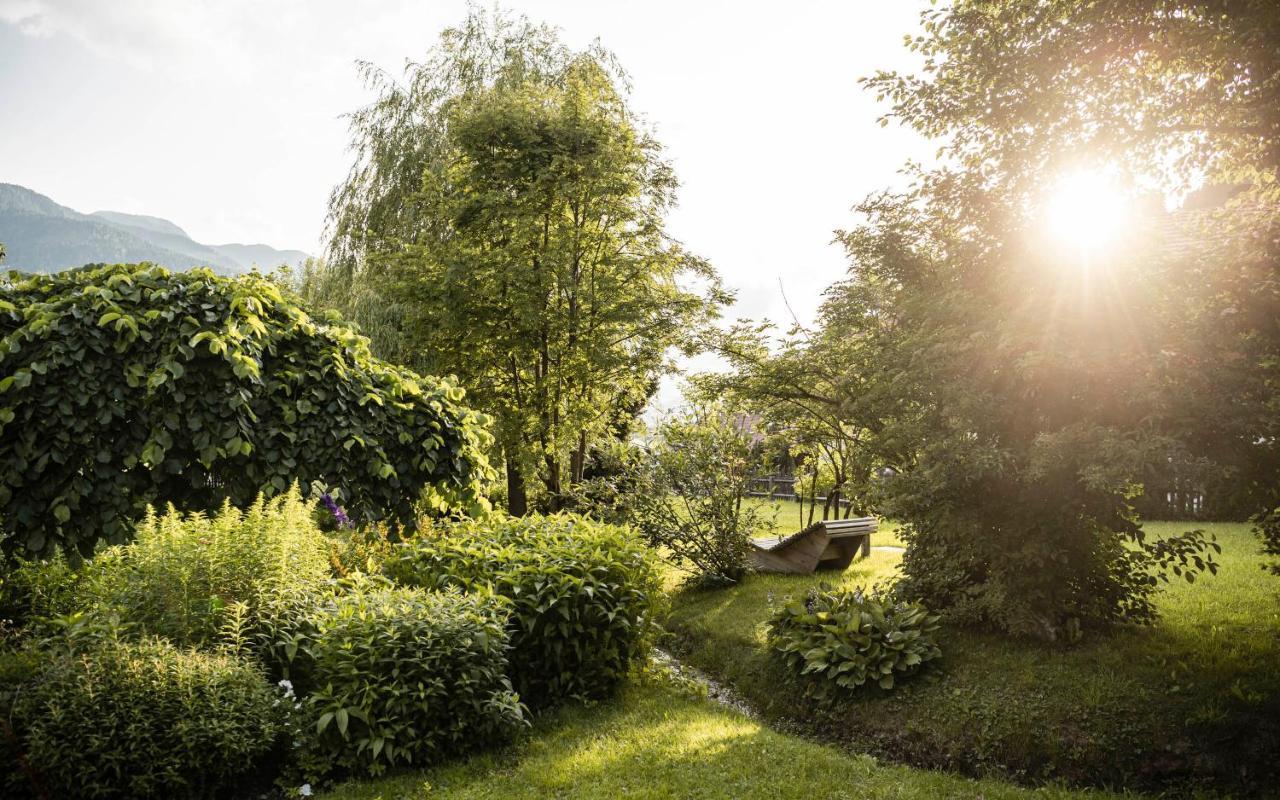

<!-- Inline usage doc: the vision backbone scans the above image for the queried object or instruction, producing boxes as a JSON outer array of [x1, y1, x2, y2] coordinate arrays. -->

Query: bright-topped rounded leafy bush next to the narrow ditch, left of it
[[387, 515, 660, 705]]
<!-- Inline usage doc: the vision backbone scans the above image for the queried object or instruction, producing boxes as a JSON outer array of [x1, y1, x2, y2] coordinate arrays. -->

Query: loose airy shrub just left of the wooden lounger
[[630, 404, 760, 581]]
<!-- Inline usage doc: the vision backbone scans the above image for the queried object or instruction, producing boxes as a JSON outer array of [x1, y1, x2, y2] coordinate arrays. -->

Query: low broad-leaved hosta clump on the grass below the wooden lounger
[[768, 586, 942, 703]]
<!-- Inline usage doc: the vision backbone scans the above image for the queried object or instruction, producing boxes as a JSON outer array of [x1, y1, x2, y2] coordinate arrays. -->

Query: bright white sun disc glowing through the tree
[[1044, 170, 1129, 253]]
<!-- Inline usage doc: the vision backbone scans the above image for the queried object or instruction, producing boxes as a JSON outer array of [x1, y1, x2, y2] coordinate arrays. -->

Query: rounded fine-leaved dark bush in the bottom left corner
[[12, 639, 287, 797]]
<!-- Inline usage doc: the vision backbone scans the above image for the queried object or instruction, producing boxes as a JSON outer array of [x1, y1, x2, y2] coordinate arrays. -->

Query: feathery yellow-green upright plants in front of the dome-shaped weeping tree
[[91, 485, 330, 644]]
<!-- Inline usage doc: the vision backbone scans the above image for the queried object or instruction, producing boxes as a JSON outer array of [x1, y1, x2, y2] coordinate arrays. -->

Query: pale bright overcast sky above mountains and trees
[[0, 0, 932, 321]]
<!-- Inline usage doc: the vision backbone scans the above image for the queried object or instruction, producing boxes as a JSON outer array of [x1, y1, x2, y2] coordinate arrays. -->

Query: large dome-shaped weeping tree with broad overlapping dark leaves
[[0, 264, 492, 556]]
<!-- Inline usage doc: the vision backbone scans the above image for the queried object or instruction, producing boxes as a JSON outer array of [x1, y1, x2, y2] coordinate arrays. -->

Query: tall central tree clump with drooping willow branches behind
[[311, 10, 726, 513]]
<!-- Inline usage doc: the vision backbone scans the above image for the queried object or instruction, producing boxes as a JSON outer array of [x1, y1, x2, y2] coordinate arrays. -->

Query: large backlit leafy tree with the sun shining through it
[[829, 0, 1280, 629]]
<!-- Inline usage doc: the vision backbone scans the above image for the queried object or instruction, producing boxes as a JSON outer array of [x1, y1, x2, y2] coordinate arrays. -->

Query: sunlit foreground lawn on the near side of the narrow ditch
[[325, 685, 1126, 800]]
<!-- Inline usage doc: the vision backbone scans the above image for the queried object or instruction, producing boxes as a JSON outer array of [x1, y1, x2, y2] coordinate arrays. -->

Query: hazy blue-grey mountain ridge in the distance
[[0, 183, 307, 275]]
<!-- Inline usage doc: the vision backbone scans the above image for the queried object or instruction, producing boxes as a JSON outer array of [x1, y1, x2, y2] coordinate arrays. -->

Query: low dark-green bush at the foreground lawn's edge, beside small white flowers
[[269, 575, 525, 778]]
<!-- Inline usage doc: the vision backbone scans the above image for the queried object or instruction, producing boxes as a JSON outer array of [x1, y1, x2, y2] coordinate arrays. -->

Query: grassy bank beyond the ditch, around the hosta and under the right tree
[[668, 524, 1280, 791]]
